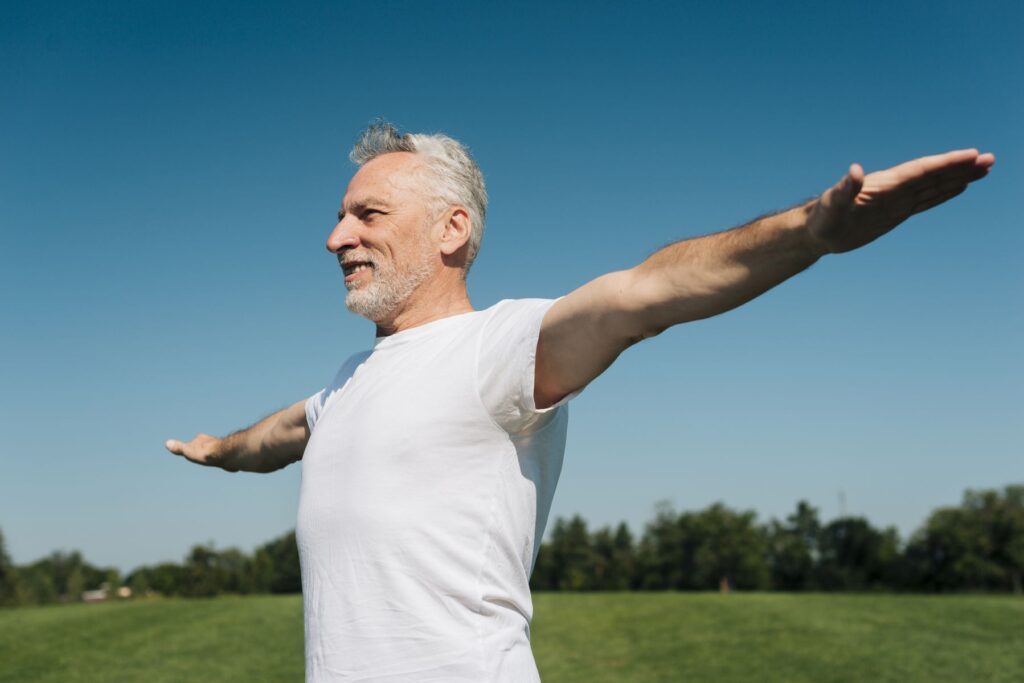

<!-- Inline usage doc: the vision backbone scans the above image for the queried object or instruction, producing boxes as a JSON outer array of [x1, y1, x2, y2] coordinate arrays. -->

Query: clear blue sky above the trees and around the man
[[0, 2, 1024, 569]]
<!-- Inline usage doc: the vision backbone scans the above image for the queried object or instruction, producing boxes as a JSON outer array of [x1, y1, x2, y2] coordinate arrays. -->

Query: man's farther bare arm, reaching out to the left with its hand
[[164, 400, 309, 472]]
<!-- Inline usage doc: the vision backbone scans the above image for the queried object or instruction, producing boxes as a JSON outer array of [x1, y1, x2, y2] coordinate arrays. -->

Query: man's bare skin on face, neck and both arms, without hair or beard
[[166, 150, 995, 472]]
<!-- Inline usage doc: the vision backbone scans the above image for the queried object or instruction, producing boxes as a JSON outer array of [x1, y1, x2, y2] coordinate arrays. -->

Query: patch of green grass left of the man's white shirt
[[0, 596, 303, 683]]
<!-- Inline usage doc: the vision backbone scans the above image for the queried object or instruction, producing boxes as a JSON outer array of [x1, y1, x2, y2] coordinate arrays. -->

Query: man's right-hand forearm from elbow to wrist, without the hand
[[633, 200, 826, 336]]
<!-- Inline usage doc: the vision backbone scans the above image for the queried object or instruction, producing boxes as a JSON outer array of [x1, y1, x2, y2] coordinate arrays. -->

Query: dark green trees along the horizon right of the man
[[530, 485, 1024, 593]]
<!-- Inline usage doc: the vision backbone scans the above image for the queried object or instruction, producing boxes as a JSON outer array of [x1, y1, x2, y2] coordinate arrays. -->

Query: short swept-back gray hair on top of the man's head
[[348, 120, 487, 273]]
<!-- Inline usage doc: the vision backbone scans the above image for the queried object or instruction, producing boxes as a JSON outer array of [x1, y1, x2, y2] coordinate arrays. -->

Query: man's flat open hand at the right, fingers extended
[[807, 150, 995, 253]]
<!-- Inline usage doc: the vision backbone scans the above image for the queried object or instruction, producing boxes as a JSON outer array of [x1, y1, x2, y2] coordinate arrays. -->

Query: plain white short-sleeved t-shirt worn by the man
[[296, 299, 575, 683]]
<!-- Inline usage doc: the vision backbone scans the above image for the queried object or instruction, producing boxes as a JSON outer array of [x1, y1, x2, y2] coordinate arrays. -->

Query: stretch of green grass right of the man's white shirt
[[531, 593, 1024, 683]]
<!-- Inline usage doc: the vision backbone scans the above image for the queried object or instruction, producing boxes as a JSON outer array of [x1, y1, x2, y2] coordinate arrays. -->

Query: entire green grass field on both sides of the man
[[0, 593, 1024, 683]]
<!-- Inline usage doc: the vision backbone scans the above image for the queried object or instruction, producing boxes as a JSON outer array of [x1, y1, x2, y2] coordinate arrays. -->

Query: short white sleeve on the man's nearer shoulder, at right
[[476, 299, 582, 433]]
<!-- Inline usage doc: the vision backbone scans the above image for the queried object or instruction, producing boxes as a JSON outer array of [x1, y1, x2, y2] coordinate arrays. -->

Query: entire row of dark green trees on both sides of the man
[[0, 485, 1024, 605]]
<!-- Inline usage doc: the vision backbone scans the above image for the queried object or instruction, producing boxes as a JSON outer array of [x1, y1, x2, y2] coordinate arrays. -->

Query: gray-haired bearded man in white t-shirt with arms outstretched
[[167, 123, 994, 682]]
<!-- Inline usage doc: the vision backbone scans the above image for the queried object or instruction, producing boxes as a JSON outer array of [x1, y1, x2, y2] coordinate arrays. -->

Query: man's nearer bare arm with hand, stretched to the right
[[535, 150, 995, 408]]
